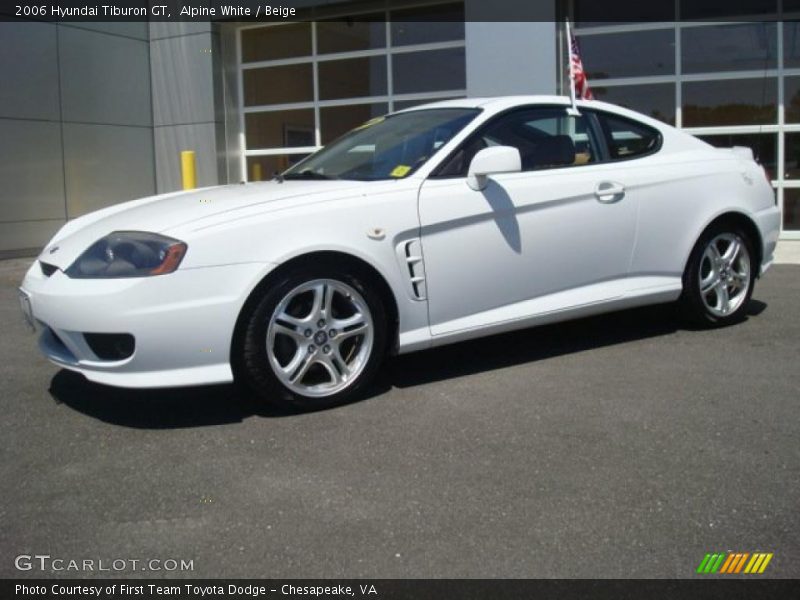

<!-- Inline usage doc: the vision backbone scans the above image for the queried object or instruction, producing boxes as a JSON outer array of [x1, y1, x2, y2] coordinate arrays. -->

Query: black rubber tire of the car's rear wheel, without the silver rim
[[681, 224, 759, 327]]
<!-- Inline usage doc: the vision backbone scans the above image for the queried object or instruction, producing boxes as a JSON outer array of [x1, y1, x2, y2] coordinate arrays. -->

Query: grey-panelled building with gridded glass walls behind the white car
[[0, 0, 800, 256]]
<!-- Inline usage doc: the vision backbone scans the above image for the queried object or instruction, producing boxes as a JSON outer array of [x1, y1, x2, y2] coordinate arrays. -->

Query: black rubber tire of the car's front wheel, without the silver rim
[[236, 265, 387, 411]]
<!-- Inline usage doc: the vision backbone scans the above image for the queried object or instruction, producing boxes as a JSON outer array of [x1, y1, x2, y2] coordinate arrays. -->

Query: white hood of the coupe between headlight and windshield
[[39, 181, 378, 269]]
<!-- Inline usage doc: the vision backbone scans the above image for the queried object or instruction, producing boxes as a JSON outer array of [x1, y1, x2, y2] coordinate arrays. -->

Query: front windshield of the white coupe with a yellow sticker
[[282, 108, 480, 181]]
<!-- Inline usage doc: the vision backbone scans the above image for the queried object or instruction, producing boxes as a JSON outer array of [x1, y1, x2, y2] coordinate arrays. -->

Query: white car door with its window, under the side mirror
[[419, 106, 636, 335]]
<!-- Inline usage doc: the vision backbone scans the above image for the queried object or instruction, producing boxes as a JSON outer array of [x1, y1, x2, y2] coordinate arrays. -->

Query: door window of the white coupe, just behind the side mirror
[[434, 106, 600, 177]]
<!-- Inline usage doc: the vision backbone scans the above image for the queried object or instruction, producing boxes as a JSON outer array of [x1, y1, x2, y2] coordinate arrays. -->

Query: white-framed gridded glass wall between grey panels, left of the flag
[[238, 2, 466, 181]]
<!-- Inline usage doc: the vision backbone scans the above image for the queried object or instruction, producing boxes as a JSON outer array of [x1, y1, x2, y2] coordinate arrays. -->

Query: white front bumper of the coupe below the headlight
[[20, 261, 274, 387]]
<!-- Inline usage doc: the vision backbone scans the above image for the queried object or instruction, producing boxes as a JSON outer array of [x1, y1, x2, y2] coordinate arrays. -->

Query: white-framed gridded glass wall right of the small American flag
[[572, 17, 800, 238]]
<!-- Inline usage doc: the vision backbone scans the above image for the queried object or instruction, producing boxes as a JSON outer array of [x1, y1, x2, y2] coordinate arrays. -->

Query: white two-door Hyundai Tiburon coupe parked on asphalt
[[20, 96, 780, 408]]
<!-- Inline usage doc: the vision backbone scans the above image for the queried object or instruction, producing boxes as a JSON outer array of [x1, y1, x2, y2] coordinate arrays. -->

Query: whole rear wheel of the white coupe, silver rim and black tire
[[681, 224, 758, 327]]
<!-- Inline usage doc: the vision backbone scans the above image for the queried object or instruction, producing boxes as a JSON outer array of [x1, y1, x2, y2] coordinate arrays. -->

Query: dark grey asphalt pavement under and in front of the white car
[[0, 261, 800, 578]]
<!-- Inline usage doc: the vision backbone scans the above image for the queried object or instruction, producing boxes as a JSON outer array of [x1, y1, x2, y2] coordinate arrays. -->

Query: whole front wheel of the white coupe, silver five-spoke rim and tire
[[237, 265, 387, 410]]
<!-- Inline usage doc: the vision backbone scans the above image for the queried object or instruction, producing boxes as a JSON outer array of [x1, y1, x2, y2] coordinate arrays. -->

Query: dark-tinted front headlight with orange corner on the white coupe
[[65, 231, 187, 279]]
